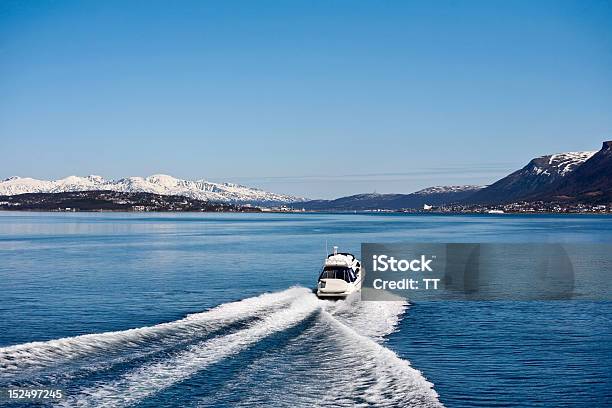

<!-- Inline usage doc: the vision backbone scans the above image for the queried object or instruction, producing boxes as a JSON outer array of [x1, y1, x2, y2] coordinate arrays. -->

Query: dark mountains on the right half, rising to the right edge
[[296, 141, 612, 211]]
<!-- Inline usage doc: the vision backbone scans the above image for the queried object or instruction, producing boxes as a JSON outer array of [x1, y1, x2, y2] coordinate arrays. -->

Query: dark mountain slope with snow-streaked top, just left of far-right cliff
[[468, 152, 596, 203]]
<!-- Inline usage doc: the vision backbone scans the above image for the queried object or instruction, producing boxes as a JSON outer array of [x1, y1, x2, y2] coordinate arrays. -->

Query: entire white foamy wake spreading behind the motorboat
[[0, 288, 442, 407]]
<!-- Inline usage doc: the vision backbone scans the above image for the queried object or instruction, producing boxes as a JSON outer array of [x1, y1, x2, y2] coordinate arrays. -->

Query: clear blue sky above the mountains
[[0, 0, 612, 198]]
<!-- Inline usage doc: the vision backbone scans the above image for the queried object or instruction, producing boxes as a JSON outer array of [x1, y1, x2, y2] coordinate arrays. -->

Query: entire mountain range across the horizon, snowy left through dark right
[[0, 141, 612, 211]]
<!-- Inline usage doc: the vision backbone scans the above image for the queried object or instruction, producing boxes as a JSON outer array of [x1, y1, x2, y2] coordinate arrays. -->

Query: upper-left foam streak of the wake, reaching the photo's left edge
[[0, 288, 305, 380]]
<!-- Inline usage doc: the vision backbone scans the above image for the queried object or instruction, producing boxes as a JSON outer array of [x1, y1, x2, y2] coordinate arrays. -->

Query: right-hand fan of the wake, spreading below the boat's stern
[[198, 298, 442, 408]]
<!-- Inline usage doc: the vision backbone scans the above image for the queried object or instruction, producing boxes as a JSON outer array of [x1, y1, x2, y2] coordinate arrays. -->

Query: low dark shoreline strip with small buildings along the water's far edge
[[0, 190, 612, 216]]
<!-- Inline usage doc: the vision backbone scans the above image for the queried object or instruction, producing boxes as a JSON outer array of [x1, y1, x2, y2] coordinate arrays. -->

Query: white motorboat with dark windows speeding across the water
[[317, 246, 363, 298]]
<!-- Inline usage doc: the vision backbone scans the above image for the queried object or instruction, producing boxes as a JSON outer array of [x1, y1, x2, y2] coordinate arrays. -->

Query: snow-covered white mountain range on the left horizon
[[0, 174, 304, 204]]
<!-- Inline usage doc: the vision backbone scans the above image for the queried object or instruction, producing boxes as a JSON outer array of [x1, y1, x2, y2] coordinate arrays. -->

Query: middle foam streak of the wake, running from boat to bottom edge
[[63, 289, 321, 407]]
